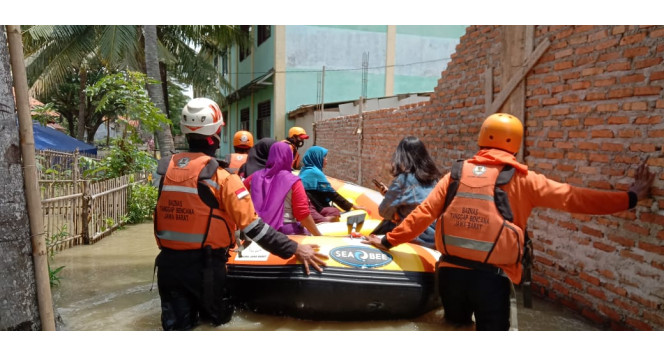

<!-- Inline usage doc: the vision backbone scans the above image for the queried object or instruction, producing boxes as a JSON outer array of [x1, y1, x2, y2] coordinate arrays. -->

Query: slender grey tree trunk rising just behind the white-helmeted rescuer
[[143, 25, 175, 157]]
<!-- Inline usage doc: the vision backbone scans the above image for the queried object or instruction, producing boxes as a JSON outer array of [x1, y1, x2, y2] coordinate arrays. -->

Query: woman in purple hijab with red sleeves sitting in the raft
[[244, 142, 321, 236]]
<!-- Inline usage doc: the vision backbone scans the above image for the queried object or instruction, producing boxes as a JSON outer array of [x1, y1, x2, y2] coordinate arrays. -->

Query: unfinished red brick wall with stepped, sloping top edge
[[315, 26, 664, 330]]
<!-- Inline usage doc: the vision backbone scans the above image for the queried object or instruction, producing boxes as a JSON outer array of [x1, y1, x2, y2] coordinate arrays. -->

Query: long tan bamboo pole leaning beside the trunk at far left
[[7, 25, 55, 331]]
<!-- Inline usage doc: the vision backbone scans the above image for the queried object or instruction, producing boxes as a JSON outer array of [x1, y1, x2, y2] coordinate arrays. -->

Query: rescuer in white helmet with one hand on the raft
[[154, 98, 326, 330]]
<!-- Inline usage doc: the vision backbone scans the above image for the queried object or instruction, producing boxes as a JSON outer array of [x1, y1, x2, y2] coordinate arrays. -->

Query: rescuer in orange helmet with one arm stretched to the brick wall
[[364, 113, 655, 330]]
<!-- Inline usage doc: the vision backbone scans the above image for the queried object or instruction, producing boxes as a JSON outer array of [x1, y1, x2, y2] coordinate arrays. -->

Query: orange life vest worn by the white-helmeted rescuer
[[155, 153, 235, 250]]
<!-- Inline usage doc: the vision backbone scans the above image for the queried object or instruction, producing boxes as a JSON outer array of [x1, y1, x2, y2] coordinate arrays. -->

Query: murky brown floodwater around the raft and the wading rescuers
[[52, 223, 598, 331]]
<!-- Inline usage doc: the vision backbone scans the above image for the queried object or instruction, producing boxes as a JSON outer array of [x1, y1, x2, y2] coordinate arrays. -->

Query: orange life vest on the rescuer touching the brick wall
[[436, 161, 524, 272]]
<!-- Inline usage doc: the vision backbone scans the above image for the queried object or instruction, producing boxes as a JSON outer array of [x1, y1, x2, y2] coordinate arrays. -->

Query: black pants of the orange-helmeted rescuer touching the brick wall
[[438, 268, 510, 331]]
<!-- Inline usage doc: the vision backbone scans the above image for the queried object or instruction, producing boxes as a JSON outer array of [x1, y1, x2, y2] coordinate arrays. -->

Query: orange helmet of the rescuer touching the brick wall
[[477, 113, 523, 154]]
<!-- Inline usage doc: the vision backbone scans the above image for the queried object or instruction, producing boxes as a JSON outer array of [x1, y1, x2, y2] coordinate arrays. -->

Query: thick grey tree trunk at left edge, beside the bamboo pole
[[0, 26, 40, 331]]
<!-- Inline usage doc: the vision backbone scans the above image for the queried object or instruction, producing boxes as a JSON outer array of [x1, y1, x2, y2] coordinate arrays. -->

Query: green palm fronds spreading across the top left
[[23, 25, 250, 147]]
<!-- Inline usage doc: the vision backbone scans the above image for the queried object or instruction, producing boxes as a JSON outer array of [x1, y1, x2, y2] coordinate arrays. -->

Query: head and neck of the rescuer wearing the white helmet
[[180, 98, 224, 156]]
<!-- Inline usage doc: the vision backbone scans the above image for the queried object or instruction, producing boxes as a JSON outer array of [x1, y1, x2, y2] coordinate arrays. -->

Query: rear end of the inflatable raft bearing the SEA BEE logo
[[227, 236, 439, 321]]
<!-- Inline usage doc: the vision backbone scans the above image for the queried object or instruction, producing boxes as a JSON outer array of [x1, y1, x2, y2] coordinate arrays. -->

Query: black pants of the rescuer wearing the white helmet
[[157, 249, 233, 331]]
